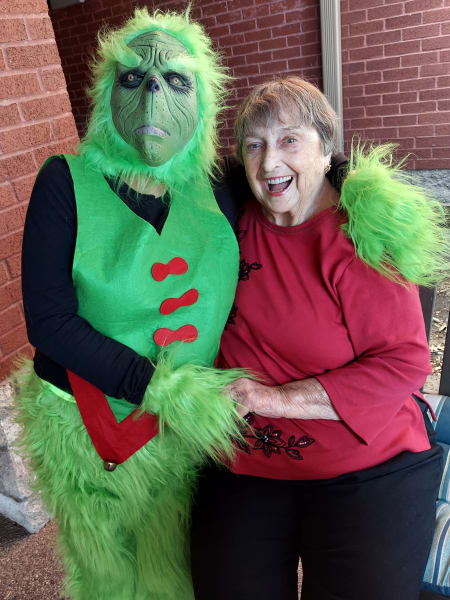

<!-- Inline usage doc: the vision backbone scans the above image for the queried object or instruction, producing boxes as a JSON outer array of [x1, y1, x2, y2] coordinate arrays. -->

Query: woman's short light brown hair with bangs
[[234, 76, 338, 160]]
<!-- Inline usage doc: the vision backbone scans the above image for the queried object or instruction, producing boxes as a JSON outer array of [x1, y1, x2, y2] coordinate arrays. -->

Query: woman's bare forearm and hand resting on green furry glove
[[227, 377, 340, 421]]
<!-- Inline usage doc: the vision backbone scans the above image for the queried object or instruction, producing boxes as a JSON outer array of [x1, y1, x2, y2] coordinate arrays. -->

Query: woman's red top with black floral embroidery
[[219, 201, 430, 479]]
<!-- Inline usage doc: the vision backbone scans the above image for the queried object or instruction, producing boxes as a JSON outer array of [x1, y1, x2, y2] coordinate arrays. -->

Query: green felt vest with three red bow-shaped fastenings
[[64, 155, 239, 417]]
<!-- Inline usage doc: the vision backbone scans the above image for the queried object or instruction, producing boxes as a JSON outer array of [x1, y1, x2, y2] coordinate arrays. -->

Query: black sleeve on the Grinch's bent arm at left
[[22, 158, 153, 404]]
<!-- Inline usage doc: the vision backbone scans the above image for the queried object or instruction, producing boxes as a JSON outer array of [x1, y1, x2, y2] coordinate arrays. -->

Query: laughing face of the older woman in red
[[242, 112, 330, 225]]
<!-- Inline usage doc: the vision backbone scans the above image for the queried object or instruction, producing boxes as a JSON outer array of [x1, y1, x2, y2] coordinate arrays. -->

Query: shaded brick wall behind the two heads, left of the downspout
[[50, 0, 322, 152]]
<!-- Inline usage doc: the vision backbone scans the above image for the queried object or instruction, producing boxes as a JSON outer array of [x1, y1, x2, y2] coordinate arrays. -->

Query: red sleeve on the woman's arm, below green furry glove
[[317, 258, 431, 444]]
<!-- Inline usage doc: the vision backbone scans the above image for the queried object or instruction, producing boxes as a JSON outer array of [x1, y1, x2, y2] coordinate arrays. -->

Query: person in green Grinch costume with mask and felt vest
[[18, 9, 246, 600]]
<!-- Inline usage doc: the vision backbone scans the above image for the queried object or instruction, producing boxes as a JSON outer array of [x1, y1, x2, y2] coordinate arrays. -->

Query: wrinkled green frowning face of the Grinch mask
[[111, 31, 198, 167]]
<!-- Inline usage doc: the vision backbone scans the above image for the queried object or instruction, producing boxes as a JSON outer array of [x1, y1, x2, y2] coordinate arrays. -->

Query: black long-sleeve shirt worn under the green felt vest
[[22, 155, 345, 404]]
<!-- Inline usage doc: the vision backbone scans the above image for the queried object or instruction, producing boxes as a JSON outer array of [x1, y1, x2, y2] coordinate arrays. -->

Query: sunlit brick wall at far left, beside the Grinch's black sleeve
[[0, 0, 78, 381]]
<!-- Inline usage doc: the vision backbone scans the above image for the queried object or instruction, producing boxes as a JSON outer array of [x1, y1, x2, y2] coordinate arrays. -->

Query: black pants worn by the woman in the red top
[[191, 412, 442, 600]]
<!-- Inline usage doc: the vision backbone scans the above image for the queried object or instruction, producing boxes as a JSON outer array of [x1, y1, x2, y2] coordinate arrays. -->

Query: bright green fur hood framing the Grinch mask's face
[[79, 8, 228, 190]]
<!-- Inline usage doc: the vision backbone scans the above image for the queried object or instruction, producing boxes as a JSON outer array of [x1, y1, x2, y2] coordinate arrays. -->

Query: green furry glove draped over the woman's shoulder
[[339, 144, 450, 286]]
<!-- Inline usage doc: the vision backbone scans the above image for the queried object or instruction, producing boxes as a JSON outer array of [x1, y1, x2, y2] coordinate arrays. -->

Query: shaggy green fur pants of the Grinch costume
[[14, 372, 209, 600]]
